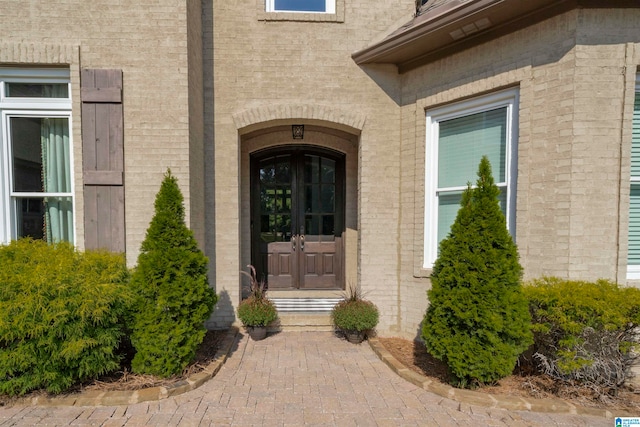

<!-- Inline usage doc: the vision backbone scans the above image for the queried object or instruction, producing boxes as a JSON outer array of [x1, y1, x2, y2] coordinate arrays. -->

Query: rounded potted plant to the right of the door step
[[331, 285, 379, 344]]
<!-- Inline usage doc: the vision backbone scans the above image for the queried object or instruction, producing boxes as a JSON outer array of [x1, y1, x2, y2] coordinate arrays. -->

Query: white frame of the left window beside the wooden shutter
[[0, 67, 76, 244]]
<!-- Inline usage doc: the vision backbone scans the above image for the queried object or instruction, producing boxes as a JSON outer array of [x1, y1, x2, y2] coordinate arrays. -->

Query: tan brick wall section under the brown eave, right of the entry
[[399, 9, 640, 335]]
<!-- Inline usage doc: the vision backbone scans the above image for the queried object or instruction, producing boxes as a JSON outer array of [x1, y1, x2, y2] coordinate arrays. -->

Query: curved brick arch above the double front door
[[233, 104, 366, 135]]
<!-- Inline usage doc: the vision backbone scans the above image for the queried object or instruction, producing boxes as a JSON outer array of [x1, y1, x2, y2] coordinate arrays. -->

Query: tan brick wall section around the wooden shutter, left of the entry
[[0, 0, 204, 265]]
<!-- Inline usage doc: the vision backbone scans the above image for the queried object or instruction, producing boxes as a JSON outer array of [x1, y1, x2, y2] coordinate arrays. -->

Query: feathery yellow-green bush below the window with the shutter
[[0, 239, 131, 395]]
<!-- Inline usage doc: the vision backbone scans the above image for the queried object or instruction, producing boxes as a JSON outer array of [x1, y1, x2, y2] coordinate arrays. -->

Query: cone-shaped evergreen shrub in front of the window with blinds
[[422, 157, 533, 387]]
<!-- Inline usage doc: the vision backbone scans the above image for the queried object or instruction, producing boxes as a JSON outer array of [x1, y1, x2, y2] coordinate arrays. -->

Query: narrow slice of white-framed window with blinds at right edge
[[627, 75, 640, 279]]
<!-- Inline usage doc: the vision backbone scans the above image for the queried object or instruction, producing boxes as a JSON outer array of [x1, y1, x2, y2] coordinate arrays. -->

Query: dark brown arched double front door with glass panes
[[251, 147, 344, 289]]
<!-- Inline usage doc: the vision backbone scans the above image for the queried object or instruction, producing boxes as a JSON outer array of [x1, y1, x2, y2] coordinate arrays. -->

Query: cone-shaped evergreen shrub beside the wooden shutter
[[131, 171, 217, 377]]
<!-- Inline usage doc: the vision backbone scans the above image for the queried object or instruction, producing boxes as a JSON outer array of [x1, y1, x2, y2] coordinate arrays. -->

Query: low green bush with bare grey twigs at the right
[[524, 277, 640, 392]]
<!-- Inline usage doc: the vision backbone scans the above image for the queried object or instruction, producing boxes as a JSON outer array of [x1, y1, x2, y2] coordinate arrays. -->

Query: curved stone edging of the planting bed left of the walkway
[[19, 327, 238, 406]]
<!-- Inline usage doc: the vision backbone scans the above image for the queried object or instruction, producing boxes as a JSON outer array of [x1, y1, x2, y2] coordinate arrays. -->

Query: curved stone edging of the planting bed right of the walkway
[[369, 338, 631, 419]]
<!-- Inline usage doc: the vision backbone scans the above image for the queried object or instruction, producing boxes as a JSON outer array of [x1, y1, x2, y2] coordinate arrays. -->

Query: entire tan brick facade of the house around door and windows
[[0, 0, 640, 337]]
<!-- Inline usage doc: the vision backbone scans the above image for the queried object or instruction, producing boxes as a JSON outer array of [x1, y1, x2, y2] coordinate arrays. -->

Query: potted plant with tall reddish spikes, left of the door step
[[238, 265, 278, 341]]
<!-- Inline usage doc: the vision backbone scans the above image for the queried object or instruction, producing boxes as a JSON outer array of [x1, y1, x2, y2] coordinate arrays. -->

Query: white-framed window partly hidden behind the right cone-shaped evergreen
[[423, 89, 518, 268]]
